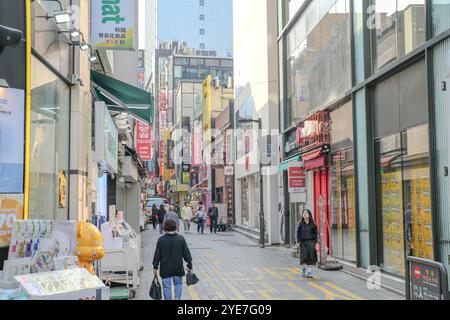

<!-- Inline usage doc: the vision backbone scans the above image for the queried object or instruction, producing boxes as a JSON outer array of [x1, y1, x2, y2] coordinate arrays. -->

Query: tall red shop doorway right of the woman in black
[[314, 168, 332, 255]]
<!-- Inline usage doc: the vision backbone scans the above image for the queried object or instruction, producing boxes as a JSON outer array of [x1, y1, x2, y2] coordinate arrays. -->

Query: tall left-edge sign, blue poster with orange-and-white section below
[[0, 88, 25, 248]]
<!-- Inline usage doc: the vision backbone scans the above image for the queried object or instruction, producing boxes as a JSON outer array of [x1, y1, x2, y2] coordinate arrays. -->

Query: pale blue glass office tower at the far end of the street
[[158, 0, 233, 57]]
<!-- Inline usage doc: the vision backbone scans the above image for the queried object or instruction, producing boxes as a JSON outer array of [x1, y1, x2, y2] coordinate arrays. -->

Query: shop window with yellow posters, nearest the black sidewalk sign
[[376, 125, 433, 275]]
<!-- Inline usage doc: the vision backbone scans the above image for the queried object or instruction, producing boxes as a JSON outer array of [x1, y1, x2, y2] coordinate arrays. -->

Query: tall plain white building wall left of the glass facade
[[233, 0, 280, 244]]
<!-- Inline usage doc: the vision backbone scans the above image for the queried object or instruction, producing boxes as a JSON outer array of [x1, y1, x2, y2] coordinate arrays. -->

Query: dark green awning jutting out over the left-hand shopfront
[[91, 70, 154, 125]]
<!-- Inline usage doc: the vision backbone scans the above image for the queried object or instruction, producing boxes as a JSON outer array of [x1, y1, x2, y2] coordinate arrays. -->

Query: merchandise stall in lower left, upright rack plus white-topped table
[[0, 220, 109, 300]]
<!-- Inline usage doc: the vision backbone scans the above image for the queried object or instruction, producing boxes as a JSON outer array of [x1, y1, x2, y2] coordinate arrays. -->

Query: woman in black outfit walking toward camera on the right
[[297, 210, 319, 278]]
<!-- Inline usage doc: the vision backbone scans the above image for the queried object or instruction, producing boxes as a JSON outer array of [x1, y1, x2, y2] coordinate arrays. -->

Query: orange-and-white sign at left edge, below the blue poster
[[0, 194, 23, 248]]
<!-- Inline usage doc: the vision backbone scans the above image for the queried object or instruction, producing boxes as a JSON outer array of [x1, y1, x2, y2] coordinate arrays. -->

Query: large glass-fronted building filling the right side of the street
[[278, 0, 450, 284]]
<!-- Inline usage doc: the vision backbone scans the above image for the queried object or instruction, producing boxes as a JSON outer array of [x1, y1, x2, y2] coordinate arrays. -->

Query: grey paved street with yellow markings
[[136, 230, 402, 300]]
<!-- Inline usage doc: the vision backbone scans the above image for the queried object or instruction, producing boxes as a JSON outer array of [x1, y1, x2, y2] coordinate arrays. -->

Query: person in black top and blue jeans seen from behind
[[153, 219, 192, 300]]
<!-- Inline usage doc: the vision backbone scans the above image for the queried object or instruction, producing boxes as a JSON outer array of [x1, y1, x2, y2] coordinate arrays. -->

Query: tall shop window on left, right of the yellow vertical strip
[[30, 57, 70, 220]]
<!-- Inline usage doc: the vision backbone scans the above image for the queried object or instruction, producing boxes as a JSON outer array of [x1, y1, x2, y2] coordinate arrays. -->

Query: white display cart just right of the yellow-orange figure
[[100, 220, 142, 289]]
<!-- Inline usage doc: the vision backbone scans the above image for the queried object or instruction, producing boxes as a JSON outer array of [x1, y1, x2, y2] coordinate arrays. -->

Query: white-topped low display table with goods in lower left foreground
[[14, 268, 110, 300]]
